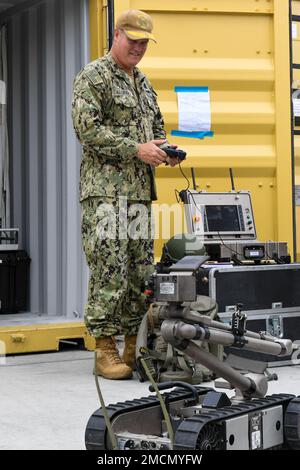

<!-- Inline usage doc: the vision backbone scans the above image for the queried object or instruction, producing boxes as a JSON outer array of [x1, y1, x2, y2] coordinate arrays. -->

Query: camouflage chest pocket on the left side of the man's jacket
[[111, 91, 137, 126]]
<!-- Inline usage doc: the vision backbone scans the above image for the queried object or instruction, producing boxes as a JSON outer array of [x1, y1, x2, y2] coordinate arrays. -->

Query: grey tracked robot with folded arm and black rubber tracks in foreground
[[85, 256, 300, 450]]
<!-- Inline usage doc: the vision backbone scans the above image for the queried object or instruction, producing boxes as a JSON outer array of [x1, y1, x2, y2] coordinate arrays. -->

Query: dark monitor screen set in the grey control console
[[205, 205, 241, 232]]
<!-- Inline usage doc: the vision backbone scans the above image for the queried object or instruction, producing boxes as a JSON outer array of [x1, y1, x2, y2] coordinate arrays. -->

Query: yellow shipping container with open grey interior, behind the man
[[0, 0, 300, 356]]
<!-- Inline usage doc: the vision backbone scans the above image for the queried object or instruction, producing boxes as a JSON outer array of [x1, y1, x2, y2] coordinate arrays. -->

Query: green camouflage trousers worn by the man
[[81, 197, 153, 338]]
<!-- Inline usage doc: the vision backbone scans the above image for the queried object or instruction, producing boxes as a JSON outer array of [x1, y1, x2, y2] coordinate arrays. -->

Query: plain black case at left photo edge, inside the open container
[[0, 250, 30, 314]]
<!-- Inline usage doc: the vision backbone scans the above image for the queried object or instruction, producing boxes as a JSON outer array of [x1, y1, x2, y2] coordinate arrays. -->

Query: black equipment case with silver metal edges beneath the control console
[[197, 263, 300, 365]]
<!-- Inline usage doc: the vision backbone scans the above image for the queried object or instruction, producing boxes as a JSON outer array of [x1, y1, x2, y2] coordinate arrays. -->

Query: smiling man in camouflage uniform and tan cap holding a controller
[[72, 10, 177, 379]]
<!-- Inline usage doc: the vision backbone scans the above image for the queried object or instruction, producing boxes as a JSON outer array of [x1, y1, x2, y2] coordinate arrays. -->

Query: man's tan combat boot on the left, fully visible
[[96, 337, 132, 380]]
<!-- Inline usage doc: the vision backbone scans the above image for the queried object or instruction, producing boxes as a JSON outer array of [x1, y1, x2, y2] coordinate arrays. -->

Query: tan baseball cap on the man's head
[[116, 10, 156, 42]]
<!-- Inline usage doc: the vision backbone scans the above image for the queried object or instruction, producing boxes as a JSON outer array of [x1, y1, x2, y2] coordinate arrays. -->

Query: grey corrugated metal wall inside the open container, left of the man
[[8, 0, 89, 318]]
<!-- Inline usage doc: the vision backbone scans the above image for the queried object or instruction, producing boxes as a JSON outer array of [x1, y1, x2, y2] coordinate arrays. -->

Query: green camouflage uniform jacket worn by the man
[[72, 53, 165, 201]]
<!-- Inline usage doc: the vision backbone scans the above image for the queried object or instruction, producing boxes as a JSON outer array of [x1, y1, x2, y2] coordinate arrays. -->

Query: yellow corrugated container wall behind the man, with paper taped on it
[[91, 0, 293, 256]]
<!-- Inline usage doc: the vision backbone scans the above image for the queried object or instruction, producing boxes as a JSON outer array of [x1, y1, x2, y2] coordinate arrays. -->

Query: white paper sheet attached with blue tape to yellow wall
[[177, 88, 211, 132]]
